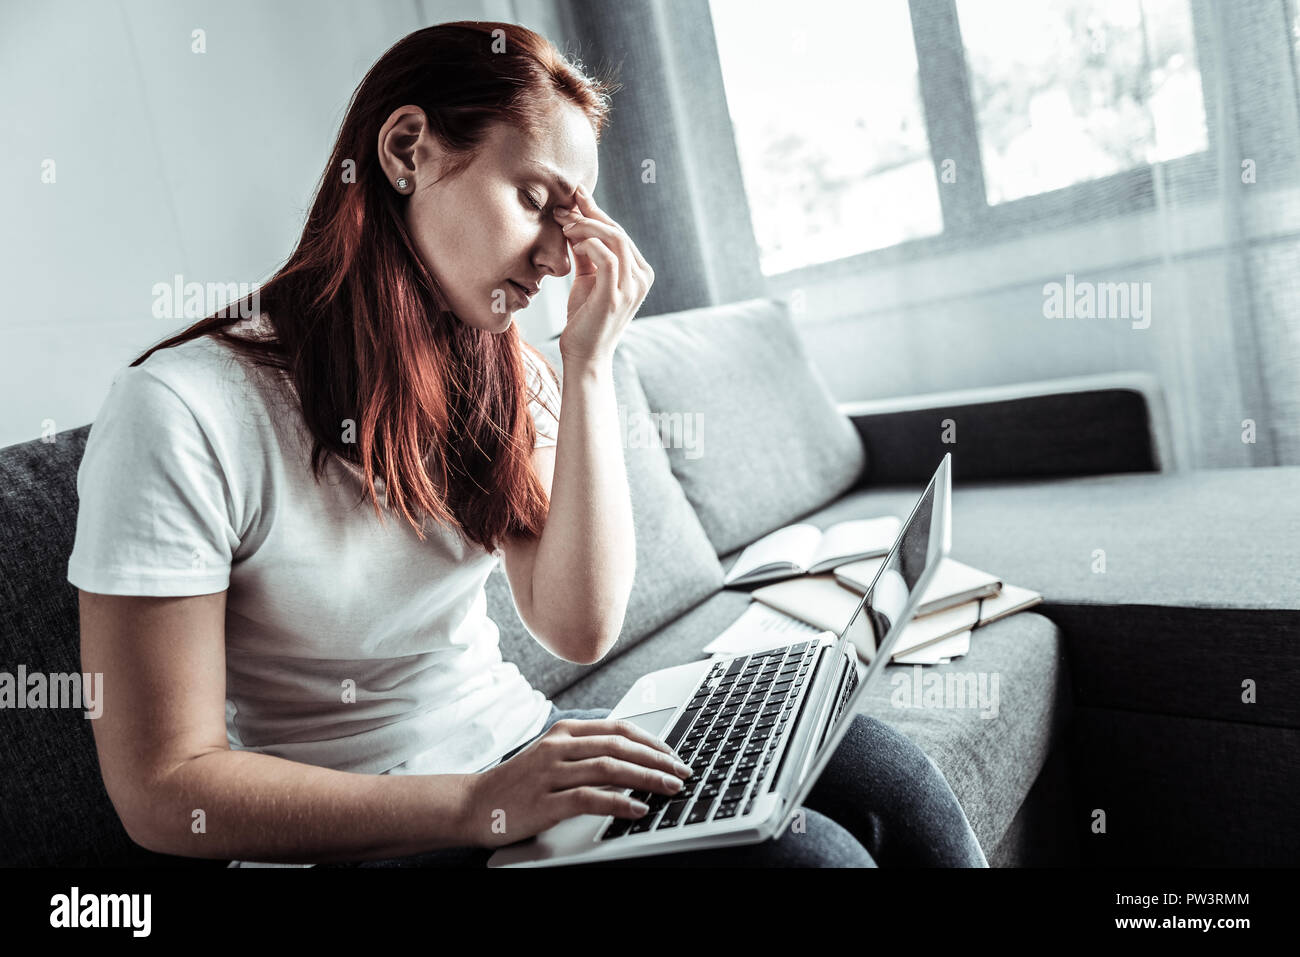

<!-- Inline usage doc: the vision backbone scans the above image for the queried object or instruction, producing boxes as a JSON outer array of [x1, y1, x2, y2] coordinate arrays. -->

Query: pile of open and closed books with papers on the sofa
[[705, 515, 1043, 664]]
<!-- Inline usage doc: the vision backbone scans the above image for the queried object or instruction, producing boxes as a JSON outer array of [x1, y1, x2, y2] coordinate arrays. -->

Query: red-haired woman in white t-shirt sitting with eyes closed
[[69, 23, 984, 866]]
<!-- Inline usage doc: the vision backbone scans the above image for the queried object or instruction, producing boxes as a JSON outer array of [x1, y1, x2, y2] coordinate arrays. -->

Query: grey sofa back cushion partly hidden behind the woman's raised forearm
[[486, 341, 722, 696]]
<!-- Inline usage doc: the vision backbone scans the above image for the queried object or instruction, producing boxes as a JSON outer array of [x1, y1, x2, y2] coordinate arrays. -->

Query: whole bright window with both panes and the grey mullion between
[[710, 0, 1206, 277]]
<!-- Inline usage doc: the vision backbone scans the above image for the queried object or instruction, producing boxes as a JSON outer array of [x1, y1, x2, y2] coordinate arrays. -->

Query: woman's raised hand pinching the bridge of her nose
[[555, 186, 654, 361]]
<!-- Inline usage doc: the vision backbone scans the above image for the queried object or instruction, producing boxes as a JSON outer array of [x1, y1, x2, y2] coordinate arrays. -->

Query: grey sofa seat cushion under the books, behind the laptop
[[555, 590, 1070, 853]]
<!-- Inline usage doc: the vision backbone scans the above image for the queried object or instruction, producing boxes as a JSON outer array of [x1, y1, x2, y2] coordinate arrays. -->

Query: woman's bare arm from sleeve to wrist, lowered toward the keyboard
[[81, 592, 475, 863]]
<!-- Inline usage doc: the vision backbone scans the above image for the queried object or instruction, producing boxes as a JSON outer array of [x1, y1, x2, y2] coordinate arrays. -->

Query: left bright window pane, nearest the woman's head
[[710, 0, 944, 276]]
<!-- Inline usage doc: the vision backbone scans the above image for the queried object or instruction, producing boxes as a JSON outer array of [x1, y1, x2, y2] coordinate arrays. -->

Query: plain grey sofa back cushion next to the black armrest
[[619, 299, 866, 554]]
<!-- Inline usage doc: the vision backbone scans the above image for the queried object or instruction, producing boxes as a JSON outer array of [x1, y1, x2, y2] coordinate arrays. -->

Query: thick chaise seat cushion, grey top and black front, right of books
[[780, 467, 1300, 728]]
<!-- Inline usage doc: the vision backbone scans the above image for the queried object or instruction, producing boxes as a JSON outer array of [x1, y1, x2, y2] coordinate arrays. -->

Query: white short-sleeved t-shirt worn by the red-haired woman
[[68, 317, 559, 863]]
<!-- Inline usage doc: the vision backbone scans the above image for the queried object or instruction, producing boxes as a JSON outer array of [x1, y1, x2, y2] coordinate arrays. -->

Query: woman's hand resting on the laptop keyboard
[[465, 718, 688, 846]]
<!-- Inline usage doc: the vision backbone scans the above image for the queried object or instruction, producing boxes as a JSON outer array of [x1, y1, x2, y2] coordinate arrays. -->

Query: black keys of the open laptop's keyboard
[[601, 641, 820, 840]]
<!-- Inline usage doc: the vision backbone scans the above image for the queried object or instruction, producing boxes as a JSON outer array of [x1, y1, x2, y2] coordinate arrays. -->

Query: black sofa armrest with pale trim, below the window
[[840, 372, 1174, 485]]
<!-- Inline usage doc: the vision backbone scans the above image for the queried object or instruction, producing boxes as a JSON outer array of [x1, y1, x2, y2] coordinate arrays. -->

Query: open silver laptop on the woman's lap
[[488, 454, 952, 867]]
